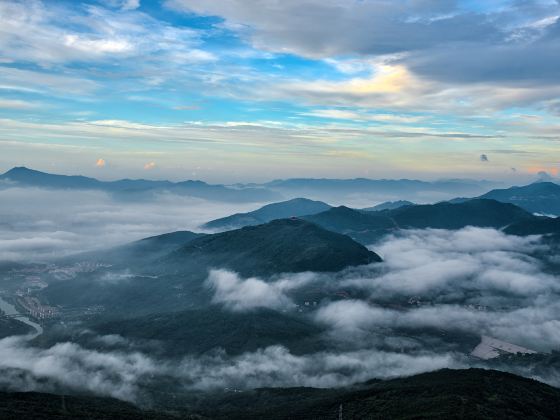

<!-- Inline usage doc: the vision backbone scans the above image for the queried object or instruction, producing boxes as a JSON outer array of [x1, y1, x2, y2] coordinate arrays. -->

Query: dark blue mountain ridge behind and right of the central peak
[[305, 199, 534, 244]]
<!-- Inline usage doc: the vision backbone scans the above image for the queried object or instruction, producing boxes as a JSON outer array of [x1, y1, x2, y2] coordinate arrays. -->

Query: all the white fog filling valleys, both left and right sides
[[0, 188, 560, 403]]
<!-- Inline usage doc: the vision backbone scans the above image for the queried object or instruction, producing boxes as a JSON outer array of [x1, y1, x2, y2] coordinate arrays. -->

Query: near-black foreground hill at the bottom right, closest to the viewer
[[180, 369, 560, 420]]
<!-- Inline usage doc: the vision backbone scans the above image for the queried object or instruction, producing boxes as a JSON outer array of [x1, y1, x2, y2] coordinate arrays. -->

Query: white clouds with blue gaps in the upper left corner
[[0, 0, 206, 66]]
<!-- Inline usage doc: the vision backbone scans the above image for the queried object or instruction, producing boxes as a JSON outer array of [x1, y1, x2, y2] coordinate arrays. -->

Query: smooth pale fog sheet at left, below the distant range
[[0, 188, 259, 262]]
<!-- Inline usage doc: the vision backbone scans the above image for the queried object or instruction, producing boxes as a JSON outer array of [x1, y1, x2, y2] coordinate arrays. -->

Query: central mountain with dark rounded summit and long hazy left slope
[[39, 219, 381, 316]]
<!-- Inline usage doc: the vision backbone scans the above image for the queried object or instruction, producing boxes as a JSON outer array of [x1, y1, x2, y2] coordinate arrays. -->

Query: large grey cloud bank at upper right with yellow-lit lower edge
[[166, 0, 560, 113]]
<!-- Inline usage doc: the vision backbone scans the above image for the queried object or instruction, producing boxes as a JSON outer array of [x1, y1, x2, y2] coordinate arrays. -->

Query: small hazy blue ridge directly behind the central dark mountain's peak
[[203, 198, 331, 229]]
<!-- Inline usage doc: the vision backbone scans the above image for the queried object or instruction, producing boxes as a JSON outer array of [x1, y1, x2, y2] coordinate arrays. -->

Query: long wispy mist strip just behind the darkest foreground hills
[[0, 336, 462, 400]]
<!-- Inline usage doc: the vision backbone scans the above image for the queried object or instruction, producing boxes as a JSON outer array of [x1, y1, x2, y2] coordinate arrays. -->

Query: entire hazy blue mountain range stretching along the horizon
[[0, 167, 506, 203]]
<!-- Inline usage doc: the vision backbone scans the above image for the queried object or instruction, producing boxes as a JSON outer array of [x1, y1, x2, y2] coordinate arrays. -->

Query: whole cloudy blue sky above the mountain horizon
[[0, 0, 560, 183]]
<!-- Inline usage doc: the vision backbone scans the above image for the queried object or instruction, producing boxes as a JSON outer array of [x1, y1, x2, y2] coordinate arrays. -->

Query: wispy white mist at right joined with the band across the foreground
[[0, 227, 560, 402]]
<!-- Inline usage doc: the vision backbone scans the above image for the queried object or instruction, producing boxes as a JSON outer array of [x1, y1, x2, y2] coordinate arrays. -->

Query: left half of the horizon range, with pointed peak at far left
[[0, 167, 281, 202]]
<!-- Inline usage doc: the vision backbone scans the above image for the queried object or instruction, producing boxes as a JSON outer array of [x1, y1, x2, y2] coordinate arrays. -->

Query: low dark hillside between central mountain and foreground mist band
[[91, 305, 326, 356]]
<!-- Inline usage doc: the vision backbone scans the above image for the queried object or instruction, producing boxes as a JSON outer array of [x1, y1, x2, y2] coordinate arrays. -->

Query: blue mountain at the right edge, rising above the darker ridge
[[479, 182, 560, 216]]
